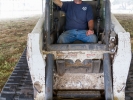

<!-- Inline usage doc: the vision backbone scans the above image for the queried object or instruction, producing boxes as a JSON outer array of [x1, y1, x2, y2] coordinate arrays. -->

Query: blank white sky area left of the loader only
[[0, 0, 42, 18]]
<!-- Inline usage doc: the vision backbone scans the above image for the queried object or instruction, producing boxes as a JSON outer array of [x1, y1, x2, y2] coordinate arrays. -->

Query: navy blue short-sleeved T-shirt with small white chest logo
[[61, 2, 93, 30]]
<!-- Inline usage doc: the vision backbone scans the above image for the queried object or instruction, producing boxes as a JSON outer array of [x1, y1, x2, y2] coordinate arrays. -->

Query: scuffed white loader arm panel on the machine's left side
[[27, 11, 46, 100]]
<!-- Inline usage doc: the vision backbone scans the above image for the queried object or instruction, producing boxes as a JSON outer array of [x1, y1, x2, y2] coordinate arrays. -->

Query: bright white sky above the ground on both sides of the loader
[[0, 0, 133, 18]]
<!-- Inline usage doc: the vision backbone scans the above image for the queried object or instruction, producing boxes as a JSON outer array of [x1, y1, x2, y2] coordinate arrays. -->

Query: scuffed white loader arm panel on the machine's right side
[[111, 15, 131, 100]]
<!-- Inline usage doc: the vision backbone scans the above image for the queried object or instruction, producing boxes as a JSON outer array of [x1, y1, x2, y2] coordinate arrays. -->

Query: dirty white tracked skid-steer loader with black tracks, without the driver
[[0, 0, 133, 100]]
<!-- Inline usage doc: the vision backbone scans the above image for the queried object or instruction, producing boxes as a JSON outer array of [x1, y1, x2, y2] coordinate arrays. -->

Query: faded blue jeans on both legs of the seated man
[[57, 29, 97, 43]]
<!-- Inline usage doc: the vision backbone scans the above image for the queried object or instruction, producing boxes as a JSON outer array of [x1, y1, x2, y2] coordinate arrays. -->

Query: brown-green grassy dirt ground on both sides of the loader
[[0, 14, 133, 92]]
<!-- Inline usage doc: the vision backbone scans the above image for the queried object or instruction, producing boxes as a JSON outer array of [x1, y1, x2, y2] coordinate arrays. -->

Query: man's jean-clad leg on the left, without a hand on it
[[57, 30, 76, 43]]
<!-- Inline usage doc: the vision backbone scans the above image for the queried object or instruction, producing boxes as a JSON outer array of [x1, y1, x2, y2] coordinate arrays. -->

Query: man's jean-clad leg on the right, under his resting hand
[[77, 30, 97, 43]]
